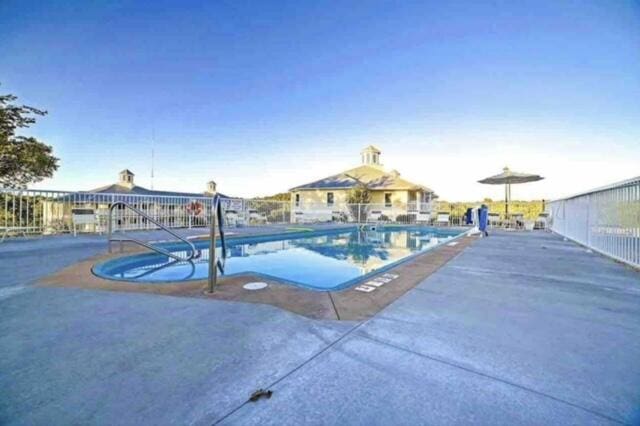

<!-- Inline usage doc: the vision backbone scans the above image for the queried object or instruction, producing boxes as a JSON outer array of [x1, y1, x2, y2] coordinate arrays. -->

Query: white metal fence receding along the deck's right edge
[[548, 176, 640, 267]]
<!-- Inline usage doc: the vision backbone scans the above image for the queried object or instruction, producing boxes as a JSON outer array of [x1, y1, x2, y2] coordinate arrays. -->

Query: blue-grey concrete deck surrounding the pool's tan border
[[0, 228, 640, 425]]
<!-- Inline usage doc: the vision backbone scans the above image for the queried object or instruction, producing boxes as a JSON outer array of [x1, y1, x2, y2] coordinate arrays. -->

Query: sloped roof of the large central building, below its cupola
[[290, 165, 433, 192]]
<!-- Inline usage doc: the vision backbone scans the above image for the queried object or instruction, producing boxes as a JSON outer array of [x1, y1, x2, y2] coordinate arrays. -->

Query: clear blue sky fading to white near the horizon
[[0, 0, 640, 200]]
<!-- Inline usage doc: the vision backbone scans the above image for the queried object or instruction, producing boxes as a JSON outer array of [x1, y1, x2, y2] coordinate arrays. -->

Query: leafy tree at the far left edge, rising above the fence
[[0, 88, 58, 188]]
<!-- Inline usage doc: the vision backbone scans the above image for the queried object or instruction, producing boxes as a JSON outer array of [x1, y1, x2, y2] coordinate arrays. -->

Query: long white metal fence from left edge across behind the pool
[[0, 189, 455, 240]]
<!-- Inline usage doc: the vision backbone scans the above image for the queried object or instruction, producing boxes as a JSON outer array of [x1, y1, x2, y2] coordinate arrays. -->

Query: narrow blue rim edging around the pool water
[[91, 224, 471, 292]]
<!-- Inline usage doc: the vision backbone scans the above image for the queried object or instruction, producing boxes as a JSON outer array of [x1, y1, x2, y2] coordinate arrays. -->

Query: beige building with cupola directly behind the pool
[[289, 145, 437, 222]]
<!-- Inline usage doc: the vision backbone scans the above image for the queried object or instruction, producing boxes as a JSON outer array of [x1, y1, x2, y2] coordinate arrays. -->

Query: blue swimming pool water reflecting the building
[[93, 227, 463, 290]]
